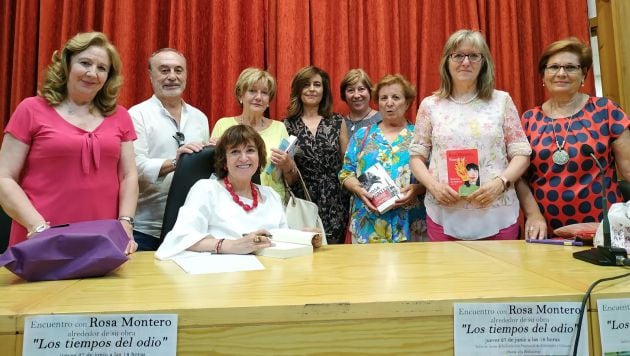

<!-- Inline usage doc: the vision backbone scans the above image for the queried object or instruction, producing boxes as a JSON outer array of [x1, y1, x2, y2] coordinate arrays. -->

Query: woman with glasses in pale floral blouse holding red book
[[410, 30, 531, 241]]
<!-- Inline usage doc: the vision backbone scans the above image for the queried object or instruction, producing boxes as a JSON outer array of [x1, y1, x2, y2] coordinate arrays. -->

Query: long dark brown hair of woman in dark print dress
[[287, 66, 332, 117]]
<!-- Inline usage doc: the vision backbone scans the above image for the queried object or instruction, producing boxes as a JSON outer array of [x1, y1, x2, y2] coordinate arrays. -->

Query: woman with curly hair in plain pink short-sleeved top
[[0, 32, 138, 253]]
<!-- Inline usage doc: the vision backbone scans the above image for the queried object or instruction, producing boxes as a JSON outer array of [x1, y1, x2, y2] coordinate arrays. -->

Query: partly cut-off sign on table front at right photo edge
[[597, 298, 630, 355]]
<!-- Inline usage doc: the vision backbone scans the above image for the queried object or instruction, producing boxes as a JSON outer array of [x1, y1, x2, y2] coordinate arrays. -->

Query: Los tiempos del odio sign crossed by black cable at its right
[[453, 302, 588, 356]]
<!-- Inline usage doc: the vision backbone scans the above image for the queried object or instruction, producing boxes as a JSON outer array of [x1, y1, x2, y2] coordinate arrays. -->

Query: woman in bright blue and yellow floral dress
[[339, 74, 425, 243]]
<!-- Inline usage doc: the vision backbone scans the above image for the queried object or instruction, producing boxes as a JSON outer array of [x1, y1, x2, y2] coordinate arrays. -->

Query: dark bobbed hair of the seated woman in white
[[214, 125, 267, 179]]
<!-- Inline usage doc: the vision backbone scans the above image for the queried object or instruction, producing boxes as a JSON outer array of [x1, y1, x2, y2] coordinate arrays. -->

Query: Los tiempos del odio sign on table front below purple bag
[[22, 314, 177, 356]]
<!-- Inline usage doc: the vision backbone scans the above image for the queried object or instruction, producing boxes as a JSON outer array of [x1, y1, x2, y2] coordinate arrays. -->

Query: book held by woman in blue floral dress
[[358, 162, 400, 214]]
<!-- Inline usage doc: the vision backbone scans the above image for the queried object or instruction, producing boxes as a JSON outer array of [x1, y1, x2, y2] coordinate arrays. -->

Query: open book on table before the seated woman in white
[[256, 229, 318, 258]]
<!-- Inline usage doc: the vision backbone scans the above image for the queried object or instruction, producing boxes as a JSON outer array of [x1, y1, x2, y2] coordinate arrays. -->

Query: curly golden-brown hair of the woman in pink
[[39, 32, 123, 116]]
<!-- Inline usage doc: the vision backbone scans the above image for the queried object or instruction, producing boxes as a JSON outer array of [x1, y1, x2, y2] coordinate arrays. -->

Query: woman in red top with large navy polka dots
[[517, 38, 630, 239]]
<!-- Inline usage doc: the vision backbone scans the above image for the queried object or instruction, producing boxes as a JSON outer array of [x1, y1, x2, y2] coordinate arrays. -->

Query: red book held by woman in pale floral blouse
[[446, 148, 479, 197]]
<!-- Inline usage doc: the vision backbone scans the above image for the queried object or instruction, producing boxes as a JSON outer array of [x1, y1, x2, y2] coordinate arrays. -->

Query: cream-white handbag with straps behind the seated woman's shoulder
[[284, 169, 328, 245]]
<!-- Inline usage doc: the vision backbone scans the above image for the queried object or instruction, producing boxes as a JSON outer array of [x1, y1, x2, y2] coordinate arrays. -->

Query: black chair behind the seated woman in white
[[160, 146, 260, 242]]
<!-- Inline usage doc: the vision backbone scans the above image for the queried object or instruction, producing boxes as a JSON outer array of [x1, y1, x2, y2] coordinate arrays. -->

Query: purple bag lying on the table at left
[[0, 220, 129, 281]]
